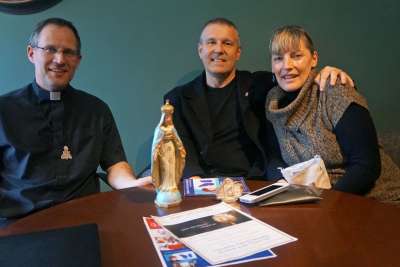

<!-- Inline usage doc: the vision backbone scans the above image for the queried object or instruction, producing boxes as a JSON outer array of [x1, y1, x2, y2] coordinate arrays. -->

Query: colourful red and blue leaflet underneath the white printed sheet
[[143, 217, 276, 267]]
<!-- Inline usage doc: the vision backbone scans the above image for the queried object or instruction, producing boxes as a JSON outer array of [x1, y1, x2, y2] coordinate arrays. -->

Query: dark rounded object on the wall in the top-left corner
[[0, 0, 61, 15]]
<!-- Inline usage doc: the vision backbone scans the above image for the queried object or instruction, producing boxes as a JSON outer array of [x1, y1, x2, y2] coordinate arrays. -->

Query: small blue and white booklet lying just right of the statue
[[183, 177, 250, 196]]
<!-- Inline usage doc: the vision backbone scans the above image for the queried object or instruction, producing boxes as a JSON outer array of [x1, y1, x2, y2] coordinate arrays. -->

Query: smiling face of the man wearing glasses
[[27, 24, 81, 91]]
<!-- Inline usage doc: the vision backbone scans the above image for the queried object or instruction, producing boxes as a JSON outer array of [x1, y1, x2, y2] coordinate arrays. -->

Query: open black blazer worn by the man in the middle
[[164, 71, 274, 178]]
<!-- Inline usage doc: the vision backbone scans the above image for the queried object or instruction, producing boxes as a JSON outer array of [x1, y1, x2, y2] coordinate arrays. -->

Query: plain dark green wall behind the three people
[[0, 0, 400, 174]]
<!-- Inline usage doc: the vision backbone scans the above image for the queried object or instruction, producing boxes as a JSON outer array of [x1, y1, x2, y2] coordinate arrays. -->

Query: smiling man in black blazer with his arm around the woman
[[164, 18, 352, 181]]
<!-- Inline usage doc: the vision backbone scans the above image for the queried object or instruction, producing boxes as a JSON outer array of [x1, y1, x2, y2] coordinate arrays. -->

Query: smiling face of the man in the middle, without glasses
[[198, 23, 241, 86]]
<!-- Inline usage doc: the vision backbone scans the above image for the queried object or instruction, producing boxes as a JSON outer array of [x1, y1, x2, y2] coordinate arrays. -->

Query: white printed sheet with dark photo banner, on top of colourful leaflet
[[152, 202, 297, 265]]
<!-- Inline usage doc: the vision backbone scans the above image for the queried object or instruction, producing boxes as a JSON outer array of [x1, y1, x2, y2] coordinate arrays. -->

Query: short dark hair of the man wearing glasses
[[28, 18, 81, 55]]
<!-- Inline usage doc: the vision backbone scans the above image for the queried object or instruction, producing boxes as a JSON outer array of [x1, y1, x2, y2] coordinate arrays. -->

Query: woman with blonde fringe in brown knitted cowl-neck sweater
[[266, 26, 400, 204]]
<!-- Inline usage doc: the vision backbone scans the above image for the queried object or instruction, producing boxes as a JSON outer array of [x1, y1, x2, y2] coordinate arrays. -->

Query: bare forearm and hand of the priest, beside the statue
[[107, 161, 152, 189]]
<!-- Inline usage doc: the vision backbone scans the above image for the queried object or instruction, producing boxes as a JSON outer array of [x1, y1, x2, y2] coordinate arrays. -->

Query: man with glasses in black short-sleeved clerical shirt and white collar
[[0, 18, 150, 228]]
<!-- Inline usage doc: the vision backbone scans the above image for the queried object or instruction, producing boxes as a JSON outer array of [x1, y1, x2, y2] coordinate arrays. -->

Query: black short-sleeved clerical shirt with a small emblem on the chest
[[0, 82, 126, 218]]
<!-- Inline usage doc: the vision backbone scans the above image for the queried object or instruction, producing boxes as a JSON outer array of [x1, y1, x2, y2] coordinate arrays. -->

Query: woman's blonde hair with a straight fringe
[[269, 25, 315, 55]]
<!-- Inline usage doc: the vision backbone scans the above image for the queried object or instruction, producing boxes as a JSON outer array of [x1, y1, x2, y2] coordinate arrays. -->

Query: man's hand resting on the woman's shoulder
[[314, 66, 354, 91]]
